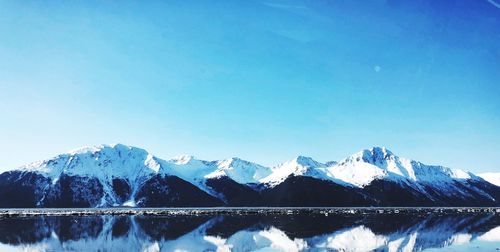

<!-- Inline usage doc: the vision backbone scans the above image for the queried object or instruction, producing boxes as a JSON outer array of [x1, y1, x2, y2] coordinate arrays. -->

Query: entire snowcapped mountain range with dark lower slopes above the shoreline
[[0, 144, 500, 208]]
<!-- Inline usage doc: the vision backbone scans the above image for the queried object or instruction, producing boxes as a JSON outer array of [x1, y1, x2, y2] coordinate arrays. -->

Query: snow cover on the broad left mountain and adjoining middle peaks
[[19, 144, 272, 206]]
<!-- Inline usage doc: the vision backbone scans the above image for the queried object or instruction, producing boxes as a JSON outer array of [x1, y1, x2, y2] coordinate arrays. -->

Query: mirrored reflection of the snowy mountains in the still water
[[0, 213, 500, 251]]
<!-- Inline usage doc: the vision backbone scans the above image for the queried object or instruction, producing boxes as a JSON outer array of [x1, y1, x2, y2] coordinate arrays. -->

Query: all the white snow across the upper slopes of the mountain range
[[14, 144, 488, 197]]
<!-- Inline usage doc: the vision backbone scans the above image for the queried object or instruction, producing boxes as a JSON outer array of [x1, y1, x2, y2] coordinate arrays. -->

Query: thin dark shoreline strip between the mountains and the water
[[0, 207, 500, 218]]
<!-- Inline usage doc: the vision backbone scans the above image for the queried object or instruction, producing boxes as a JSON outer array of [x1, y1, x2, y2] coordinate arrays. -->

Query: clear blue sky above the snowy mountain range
[[0, 0, 500, 172]]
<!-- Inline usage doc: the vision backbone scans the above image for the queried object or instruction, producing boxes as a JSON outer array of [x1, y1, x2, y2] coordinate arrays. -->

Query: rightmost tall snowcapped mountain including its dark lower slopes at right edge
[[322, 147, 499, 206]]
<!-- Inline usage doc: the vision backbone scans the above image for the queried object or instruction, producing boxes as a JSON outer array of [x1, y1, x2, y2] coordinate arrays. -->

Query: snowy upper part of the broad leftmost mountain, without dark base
[[19, 144, 165, 205]]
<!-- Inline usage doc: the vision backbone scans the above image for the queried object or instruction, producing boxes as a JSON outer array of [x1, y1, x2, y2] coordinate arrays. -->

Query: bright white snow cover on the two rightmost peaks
[[260, 147, 477, 190]]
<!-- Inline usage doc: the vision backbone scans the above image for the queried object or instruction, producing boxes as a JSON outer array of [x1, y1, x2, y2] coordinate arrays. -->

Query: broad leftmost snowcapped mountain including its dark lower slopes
[[0, 144, 223, 207]]
